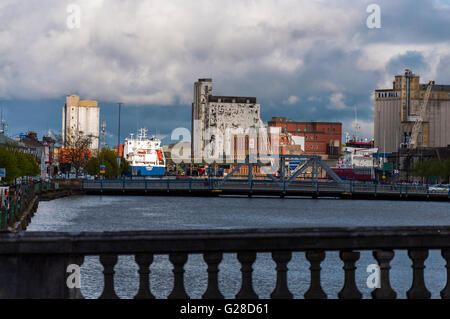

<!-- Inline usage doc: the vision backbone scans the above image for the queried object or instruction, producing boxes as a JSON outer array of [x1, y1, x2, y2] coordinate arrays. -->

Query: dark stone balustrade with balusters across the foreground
[[0, 227, 450, 299]]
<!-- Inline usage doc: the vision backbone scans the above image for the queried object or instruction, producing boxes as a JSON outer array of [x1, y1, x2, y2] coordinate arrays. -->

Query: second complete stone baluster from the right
[[372, 250, 397, 299]]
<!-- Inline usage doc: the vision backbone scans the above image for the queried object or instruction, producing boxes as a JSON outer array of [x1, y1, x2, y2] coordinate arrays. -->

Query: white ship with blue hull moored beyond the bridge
[[123, 128, 166, 176]]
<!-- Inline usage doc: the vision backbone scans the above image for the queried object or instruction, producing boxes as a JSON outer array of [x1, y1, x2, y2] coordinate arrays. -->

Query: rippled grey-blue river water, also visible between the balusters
[[28, 196, 450, 298]]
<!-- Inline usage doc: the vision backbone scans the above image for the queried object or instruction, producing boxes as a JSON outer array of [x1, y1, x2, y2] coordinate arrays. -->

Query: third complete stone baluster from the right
[[338, 251, 362, 299]]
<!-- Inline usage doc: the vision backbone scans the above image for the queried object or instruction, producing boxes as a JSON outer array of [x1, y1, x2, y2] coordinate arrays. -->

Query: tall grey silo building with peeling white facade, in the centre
[[191, 79, 264, 162]]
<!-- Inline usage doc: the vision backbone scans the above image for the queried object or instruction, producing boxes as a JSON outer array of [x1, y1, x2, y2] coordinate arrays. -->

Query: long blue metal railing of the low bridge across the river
[[82, 178, 450, 201]]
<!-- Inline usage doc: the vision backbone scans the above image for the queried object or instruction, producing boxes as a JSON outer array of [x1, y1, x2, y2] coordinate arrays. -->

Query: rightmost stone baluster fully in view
[[406, 249, 431, 299]]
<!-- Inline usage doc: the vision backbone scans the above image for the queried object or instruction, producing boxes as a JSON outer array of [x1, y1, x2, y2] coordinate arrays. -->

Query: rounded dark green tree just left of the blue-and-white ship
[[86, 148, 130, 178]]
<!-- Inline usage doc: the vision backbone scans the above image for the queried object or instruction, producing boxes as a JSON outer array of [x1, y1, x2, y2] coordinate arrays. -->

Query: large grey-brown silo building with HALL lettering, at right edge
[[374, 70, 450, 153]]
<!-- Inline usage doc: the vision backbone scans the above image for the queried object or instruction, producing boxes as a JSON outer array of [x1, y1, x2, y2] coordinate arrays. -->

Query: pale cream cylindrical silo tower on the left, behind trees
[[62, 95, 100, 150]]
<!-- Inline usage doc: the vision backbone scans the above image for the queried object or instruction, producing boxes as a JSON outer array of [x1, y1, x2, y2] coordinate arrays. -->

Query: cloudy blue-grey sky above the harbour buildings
[[0, 0, 450, 145]]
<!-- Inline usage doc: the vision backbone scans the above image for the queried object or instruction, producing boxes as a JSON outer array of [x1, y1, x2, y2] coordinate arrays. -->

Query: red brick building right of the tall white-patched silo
[[268, 117, 342, 158]]
